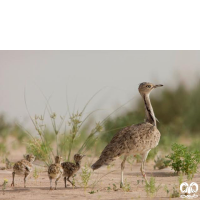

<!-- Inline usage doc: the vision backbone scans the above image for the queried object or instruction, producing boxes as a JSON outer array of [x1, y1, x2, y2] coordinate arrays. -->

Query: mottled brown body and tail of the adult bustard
[[91, 123, 160, 170]]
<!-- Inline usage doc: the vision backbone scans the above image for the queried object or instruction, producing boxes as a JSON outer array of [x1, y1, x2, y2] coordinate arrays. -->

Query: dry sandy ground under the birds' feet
[[0, 149, 200, 200]]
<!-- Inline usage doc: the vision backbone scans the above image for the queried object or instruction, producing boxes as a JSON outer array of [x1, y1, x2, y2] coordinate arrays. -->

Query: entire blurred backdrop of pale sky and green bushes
[[0, 51, 200, 162]]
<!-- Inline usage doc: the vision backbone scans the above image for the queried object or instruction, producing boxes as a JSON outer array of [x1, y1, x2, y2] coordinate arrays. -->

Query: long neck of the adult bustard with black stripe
[[143, 94, 156, 126]]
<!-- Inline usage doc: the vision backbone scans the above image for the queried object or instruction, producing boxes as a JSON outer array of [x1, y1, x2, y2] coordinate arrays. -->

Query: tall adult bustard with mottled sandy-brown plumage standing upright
[[91, 82, 163, 187]]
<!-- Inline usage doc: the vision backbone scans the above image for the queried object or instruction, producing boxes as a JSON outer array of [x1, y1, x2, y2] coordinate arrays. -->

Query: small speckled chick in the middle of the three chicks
[[48, 156, 63, 190]]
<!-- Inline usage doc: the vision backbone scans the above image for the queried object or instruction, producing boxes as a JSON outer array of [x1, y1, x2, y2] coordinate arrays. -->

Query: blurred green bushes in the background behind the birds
[[0, 81, 200, 163]]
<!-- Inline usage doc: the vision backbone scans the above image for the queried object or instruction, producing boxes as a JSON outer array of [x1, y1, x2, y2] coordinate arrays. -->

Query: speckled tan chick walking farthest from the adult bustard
[[11, 154, 35, 187]]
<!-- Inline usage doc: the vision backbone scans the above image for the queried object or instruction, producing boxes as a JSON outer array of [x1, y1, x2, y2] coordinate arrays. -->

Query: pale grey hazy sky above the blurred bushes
[[0, 51, 200, 130]]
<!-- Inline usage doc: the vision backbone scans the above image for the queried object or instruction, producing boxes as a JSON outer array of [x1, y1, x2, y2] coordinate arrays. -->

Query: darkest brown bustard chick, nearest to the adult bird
[[61, 154, 85, 188]]
